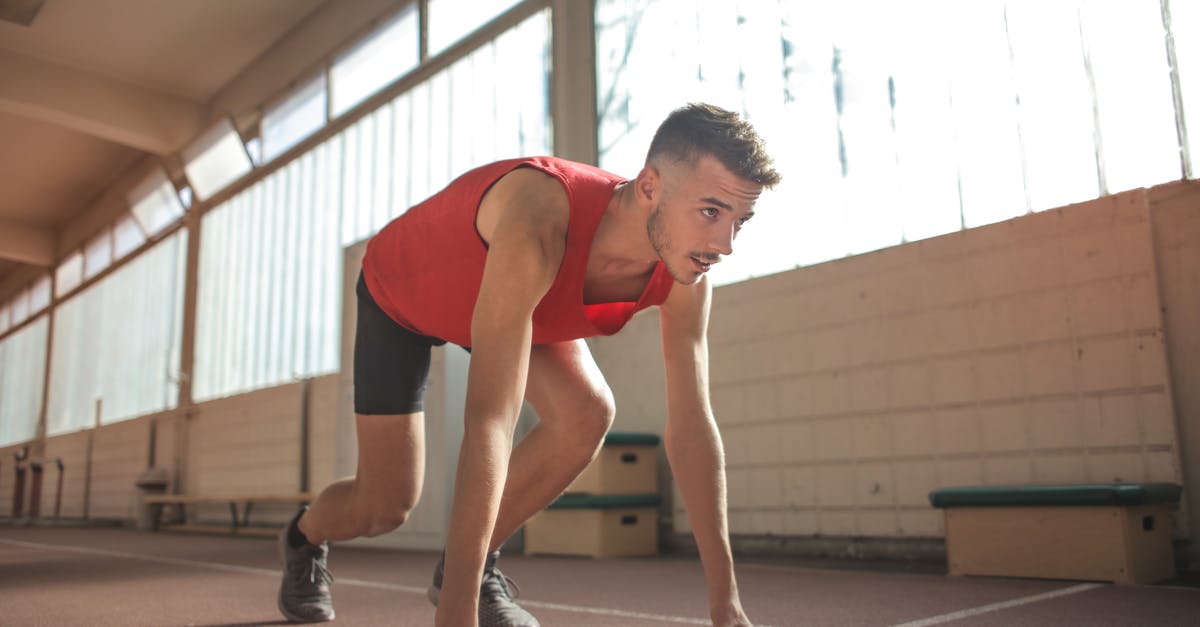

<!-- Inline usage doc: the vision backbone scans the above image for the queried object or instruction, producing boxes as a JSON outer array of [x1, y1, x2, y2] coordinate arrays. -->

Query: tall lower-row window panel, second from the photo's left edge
[[47, 231, 187, 435]]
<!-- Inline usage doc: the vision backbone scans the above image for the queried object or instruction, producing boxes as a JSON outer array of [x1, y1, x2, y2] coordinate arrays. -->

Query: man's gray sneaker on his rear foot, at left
[[278, 521, 334, 622]]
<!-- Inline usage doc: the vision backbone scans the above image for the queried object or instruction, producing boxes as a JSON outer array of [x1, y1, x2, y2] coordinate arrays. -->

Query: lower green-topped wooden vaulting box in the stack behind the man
[[524, 494, 660, 557]]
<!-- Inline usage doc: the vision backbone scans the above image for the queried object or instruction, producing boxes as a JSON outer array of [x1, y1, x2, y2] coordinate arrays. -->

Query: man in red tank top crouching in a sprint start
[[278, 105, 780, 627]]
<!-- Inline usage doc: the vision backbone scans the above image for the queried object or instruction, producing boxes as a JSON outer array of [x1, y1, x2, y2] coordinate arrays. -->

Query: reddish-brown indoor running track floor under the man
[[0, 526, 1200, 627]]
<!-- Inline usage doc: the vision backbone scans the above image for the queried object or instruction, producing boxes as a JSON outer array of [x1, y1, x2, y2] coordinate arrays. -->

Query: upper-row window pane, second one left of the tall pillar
[[329, 2, 419, 117]]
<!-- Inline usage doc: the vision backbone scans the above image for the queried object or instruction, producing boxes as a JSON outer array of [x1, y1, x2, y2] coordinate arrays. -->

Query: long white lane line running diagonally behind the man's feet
[[0, 538, 709, 625]]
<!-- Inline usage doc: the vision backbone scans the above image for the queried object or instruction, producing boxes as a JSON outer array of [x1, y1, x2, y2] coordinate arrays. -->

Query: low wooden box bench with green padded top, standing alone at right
[[929, 483, 1183, 584]]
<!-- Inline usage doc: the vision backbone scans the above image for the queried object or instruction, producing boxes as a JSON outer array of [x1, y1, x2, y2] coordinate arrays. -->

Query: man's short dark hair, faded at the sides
[[646, 102, 782, 187]]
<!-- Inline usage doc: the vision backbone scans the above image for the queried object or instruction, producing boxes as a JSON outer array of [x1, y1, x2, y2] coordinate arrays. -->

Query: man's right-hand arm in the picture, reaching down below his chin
[[659, 276, 750, 627]]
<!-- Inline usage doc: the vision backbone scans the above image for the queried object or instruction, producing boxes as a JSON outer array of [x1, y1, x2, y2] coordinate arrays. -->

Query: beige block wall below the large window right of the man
[[592, 183, 1181, 538]]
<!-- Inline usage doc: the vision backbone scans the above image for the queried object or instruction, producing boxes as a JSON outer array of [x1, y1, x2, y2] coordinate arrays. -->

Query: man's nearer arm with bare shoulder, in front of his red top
[[437, 171, 569, 626]]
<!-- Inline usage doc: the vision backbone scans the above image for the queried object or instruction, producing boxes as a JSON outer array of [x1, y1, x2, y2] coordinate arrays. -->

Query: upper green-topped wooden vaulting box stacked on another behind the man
[[566, 432, 659, 495]]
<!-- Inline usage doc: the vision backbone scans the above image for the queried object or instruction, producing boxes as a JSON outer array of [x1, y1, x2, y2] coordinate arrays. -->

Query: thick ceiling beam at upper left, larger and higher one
[[0, 50, 204, 155]]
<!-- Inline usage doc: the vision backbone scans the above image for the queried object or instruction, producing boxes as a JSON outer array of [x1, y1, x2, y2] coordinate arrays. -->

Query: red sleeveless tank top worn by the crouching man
[[362, 157, 673, 346]]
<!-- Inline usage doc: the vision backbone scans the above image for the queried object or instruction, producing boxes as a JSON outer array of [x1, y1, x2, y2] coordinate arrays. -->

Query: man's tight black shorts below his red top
[[354, 273, 445, 416]]
